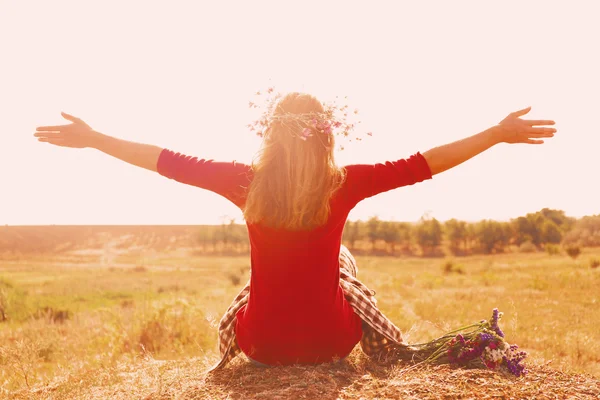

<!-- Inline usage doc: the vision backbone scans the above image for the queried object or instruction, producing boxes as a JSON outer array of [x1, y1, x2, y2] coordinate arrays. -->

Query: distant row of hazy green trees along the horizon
[[197, 208, 600, 256]]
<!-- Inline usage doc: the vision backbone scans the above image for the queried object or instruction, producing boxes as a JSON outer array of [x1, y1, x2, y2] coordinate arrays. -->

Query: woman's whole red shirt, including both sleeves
[[157, 149, 431, 365]]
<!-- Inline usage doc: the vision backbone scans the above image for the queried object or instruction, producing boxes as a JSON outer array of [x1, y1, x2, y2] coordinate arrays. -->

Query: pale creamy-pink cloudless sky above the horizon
[[0, 0, 600, 225]]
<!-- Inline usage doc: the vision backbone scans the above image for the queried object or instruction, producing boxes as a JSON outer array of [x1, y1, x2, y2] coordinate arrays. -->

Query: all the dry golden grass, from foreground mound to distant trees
[[0, 245, 600, 399]]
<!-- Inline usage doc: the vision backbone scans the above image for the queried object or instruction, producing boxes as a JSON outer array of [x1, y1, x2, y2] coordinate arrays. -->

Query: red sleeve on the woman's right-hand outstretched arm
[[344, 153, 431, 207]]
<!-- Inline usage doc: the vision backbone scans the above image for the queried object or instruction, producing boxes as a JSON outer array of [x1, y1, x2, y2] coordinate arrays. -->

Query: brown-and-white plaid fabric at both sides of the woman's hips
[[210, 245, 411, 371]]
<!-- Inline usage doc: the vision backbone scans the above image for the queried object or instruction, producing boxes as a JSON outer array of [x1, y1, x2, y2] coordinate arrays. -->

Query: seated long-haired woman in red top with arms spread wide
[[35, 93, 556, 365]]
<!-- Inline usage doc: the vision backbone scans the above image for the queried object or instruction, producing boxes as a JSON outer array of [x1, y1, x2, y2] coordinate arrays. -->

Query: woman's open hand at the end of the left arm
[[33, 112, 98, 149]]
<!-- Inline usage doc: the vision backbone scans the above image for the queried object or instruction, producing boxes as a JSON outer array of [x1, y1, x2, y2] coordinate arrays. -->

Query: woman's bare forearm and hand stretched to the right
[[423, 107, 556, 175]]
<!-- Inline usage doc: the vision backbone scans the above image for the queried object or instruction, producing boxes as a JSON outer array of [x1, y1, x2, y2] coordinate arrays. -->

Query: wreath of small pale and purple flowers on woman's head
[[248, 87, 372, 150]]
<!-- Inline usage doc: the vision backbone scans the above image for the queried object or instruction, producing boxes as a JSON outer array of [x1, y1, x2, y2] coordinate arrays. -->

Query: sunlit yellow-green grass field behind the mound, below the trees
[[0, 250, 600, 398]]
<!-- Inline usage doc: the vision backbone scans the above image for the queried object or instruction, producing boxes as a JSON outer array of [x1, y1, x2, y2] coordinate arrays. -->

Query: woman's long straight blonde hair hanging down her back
[[244, 93, 344, 231]]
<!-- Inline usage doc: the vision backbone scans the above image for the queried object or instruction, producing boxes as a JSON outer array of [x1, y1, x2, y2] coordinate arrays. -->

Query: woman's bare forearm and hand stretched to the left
[[34, 113, 163, 171]]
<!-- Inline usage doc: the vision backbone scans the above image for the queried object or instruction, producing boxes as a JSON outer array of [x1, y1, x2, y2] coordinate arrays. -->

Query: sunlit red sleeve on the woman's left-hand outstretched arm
[[156, 149, 251, 207]]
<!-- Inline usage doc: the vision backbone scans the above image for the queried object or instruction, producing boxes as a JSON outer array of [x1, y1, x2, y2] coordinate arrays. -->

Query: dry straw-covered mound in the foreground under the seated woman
[[10, 351, 600, 400]]
